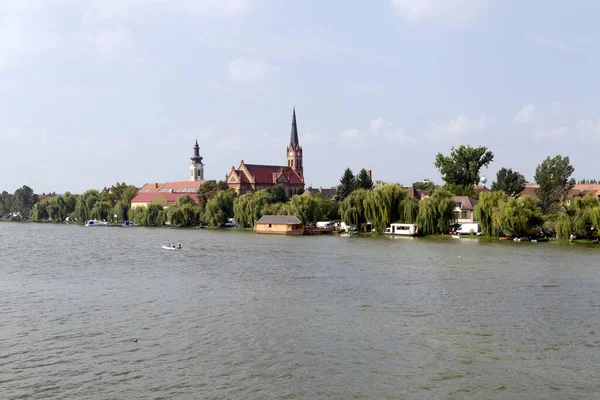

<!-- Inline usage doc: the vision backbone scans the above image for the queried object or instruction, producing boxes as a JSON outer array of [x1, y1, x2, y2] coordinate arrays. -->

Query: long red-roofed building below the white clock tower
[[131, 181, 204, 209]]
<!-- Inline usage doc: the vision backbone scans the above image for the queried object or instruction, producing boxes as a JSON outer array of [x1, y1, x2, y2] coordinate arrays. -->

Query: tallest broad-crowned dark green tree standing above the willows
[[434, 145, 494, 195]]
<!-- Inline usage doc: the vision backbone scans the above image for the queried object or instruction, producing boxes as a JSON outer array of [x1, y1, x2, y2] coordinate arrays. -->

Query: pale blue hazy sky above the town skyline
[[0, 0, 600, 193]]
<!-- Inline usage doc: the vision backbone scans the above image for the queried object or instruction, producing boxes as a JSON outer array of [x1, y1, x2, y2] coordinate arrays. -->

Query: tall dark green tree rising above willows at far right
[[534, 155, 575, 213]]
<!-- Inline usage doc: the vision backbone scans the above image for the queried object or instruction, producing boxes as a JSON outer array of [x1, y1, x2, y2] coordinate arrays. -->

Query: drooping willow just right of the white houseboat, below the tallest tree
[[417, 188, 456, 235]]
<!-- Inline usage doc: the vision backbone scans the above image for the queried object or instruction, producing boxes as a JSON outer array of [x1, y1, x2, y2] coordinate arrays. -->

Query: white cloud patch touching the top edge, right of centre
[[391, 0, 488, 25]]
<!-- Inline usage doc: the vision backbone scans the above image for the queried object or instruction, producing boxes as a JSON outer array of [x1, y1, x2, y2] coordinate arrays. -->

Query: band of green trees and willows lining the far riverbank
[[0, 145, 600, 243]]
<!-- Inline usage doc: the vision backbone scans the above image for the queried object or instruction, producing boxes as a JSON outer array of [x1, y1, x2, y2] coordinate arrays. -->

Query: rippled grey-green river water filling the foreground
[[0, 223, 600, 399]]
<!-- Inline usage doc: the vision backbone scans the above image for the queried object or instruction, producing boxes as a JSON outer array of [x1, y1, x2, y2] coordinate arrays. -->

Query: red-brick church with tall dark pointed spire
[[225, 107, 304, 197]]
